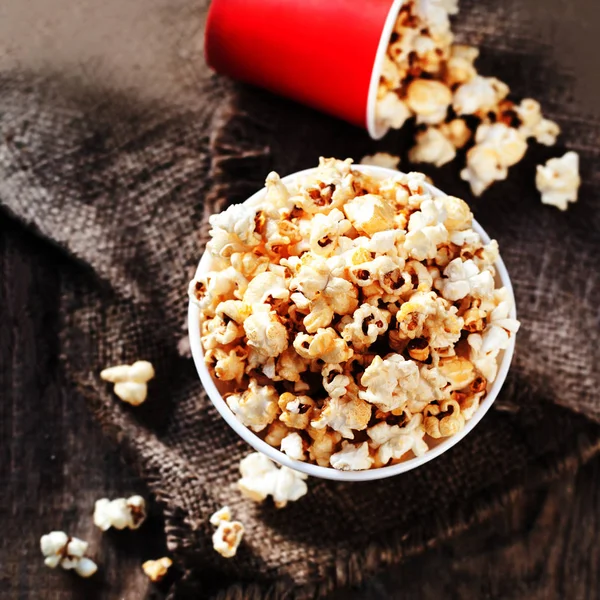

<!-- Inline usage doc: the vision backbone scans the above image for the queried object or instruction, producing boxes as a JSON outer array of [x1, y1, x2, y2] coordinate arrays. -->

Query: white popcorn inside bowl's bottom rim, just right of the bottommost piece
[[367, 414, 428, 465]]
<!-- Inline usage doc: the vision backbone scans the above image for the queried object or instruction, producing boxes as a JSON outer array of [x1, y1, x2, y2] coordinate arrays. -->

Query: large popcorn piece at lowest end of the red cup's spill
[[460, 123, 527, 196]]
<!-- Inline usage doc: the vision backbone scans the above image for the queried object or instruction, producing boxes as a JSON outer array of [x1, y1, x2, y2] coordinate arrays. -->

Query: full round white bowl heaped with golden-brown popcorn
[[189, 159, 519, 481]]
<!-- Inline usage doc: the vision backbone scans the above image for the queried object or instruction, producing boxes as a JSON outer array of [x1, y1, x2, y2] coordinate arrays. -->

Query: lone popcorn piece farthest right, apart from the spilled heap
[[535, 152, 581, 210]]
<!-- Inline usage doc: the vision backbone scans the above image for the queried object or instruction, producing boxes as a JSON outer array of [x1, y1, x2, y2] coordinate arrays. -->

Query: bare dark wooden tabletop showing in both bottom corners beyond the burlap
[[0, 214, 600, 600]]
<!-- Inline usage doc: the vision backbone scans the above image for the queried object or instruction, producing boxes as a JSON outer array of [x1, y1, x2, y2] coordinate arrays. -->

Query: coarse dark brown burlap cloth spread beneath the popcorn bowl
[[0, 0, 600, 598]]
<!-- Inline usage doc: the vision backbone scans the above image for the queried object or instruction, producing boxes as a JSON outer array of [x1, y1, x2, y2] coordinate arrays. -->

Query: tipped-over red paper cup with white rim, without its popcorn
[[205, 0, 403, 139]]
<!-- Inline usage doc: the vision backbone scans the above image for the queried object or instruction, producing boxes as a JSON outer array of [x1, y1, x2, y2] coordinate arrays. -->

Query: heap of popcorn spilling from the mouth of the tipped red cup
[[375, 0, 560, 197]]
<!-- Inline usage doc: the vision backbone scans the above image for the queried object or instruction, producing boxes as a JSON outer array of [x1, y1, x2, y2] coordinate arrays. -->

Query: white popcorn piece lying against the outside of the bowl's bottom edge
[[238, 452, 308, 508]]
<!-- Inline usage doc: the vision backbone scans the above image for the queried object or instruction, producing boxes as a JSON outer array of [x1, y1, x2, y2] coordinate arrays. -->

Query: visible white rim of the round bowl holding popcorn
[[188, 165, 516, 481]]
